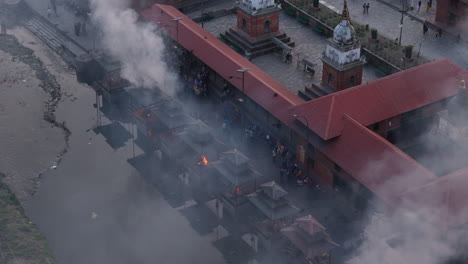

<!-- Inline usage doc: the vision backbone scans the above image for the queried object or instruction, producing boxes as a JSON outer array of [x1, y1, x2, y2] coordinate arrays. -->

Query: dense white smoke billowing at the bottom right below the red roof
[[347, 206, 459, 264]]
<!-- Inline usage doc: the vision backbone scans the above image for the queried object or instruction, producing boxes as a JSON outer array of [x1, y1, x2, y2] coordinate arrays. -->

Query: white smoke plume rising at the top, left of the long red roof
[[91, 0, 178, 94]]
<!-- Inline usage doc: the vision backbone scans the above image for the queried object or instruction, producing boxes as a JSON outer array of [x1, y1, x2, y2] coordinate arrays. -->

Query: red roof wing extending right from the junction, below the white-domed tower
[[293, 59, 464, 139]]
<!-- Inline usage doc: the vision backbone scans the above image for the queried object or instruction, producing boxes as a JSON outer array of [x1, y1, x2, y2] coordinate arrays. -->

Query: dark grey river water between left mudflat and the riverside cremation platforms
[[20, 55, 224, 264]]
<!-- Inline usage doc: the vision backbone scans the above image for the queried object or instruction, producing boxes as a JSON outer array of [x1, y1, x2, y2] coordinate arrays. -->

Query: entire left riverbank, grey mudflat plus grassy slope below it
[[0, 28, 66, 264]]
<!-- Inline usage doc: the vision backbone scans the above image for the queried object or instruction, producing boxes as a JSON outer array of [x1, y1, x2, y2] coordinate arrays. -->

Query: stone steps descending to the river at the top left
[[23, 5, 89, 68]]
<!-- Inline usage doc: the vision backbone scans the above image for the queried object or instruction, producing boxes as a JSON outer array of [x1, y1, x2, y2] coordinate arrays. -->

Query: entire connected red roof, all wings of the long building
[[142, 5, 468, 226]]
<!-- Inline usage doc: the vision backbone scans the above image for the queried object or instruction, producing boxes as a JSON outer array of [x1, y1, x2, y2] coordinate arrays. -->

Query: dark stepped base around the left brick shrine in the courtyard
[[225, 28, 295, 58]]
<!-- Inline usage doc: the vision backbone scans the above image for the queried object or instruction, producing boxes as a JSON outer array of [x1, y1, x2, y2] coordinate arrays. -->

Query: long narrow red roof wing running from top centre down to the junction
[[142, 4, 303, 127]]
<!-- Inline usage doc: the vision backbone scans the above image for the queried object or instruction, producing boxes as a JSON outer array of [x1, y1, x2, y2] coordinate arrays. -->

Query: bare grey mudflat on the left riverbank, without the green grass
[[0, 31, 70, 202]]
